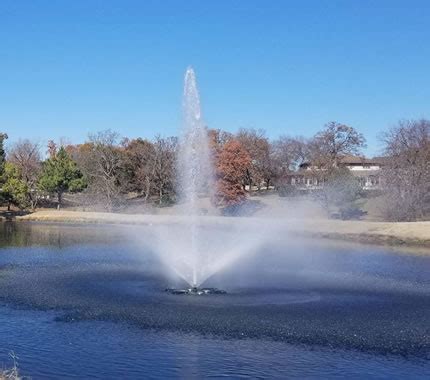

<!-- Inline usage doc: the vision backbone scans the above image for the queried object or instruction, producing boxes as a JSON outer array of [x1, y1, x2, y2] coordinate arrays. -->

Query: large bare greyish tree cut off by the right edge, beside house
[[382, 119, 430, 221]]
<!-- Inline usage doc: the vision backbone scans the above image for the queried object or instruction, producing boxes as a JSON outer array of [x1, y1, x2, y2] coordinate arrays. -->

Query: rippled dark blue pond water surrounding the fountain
[[0, 224, 430, 379]]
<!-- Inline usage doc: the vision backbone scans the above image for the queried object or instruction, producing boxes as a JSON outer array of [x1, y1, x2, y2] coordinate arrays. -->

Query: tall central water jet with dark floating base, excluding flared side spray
[[166, 67, 225, 295]]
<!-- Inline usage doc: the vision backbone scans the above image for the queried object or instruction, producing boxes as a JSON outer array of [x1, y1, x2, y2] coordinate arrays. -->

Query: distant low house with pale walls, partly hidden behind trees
[[284, 156, 384, 191]]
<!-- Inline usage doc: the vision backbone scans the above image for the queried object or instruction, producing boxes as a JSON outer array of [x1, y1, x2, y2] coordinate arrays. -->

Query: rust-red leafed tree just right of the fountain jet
[[214, 140, 251, 207]]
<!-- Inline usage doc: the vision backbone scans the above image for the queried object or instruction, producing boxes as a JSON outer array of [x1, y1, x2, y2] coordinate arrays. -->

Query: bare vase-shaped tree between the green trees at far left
[[8, 139, 41, 209]]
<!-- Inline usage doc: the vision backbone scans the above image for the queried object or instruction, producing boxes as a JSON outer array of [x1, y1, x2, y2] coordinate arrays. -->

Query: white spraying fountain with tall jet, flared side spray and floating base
[[148, 68, 267, 295]]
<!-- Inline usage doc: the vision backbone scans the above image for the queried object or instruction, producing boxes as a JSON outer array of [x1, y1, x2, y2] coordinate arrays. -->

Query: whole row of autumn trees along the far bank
[[0, 120, 430, 220]]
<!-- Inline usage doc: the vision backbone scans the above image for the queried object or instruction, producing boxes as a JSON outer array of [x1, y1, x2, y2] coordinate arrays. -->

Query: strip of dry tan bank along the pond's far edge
[[15, 210, 430, 254]]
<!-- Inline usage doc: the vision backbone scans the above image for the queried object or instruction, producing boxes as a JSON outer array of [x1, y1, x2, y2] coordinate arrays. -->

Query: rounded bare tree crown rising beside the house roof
[[310, 121, 366, 167]]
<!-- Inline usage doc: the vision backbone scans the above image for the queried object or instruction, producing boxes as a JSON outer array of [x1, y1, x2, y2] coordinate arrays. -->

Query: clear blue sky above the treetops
[[0, 0, 430, 155]]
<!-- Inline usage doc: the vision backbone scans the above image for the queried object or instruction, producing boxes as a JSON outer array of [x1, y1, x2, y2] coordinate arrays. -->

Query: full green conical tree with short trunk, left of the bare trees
[[39, 147, 86, 208]]
